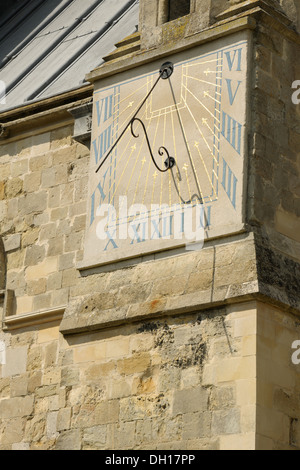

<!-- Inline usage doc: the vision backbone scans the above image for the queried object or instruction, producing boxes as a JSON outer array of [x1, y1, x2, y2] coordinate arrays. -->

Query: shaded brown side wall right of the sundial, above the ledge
[[241, 2, 300, 309]]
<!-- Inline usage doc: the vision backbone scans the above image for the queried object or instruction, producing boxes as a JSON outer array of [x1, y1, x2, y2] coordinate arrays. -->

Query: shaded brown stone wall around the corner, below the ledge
[[256, 303, 300, 450]]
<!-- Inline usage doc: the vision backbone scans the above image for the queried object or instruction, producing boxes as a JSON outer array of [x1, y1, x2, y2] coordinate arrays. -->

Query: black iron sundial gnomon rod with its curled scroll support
[[96, 62, 176, 173]]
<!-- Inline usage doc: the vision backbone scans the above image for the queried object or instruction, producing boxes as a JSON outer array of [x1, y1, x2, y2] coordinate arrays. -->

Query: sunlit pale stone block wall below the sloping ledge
[[0, 303, 256, 450]]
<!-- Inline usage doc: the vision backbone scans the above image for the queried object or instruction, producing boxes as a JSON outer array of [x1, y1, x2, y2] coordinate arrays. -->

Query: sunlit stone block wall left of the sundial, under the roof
[[0, 127, 89, 314]]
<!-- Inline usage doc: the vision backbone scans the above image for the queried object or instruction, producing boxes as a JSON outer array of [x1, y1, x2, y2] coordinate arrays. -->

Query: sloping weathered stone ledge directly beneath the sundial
[[60, 230, 300, 335]]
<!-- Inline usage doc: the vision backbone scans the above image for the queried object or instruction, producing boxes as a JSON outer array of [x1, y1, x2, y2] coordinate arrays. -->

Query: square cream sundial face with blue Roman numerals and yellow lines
[[83, 37, 248, 266]]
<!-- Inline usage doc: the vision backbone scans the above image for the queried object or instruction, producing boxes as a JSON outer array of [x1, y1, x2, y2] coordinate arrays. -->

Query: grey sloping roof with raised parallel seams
[[0, 0, 139, 112]]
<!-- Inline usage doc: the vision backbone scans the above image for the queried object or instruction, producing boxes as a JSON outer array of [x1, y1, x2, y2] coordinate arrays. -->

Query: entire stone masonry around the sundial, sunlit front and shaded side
[[0, 2, 300, 450]]
